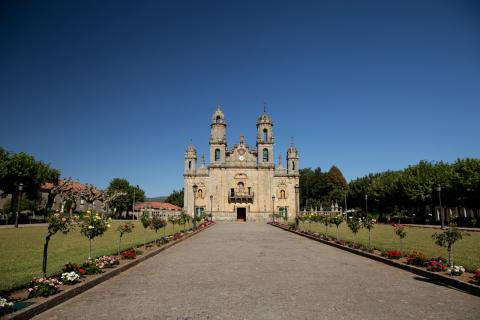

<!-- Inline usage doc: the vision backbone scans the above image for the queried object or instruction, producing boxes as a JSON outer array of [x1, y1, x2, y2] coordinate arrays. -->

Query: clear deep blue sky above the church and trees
[[0, 0, 480, 196]]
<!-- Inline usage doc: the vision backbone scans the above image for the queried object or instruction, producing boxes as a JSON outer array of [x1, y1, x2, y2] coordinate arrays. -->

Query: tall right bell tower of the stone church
[[257, 110, 274, 166]]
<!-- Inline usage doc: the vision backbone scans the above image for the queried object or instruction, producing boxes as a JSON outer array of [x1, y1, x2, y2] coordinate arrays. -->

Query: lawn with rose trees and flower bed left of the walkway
[[0, 211, 212, 315]]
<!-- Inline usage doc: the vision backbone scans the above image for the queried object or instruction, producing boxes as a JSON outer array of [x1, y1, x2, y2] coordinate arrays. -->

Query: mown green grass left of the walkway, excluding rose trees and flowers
[[0, 221, 188, 291]]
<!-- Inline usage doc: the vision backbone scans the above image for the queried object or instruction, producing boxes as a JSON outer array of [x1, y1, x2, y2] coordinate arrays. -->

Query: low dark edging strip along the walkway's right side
[[268, 222, 480, 296]]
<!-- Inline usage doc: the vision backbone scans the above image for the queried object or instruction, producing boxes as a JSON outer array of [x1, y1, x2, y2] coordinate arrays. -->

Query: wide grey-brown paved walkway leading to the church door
[[35, 223, 480, 320]]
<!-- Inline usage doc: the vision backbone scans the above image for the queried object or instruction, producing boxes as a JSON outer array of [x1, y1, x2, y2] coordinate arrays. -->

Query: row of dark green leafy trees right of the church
[[300, 158, 480, 222]]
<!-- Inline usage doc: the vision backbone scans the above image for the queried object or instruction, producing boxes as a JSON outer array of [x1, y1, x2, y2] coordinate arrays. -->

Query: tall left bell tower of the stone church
[[210, 105, 227, 164]]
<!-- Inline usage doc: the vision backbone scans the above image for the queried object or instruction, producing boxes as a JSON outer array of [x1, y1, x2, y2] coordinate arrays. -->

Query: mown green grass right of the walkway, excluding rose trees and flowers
[[300, 222, 480, 271]]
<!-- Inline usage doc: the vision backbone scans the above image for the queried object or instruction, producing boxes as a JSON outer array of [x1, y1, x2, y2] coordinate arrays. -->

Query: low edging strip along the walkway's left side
[[0, 224, 215, 320]]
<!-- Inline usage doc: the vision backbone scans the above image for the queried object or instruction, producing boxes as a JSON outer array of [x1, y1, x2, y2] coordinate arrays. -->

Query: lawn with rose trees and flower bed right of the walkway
[[272, 214, 480, 285]]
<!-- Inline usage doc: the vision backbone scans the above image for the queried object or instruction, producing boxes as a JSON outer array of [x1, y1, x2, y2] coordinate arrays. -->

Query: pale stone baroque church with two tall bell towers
[[183, 106, 299, 221]]
